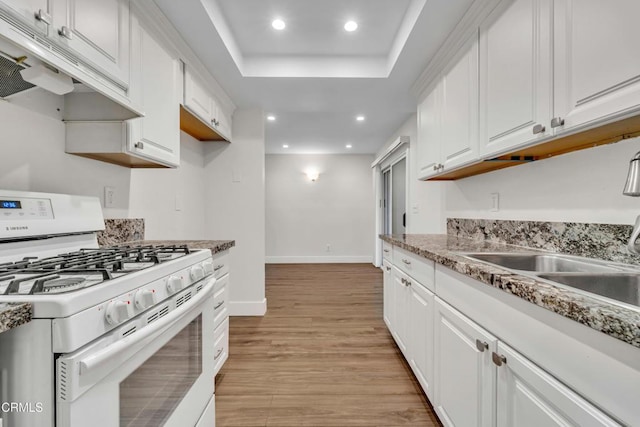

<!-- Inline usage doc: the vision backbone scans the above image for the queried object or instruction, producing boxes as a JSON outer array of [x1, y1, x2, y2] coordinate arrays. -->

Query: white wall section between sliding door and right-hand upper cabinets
[[376, 114, 448, 234]]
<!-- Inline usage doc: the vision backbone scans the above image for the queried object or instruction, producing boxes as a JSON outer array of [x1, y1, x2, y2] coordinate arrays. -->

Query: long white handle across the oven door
[[79, 277, 216, 375]]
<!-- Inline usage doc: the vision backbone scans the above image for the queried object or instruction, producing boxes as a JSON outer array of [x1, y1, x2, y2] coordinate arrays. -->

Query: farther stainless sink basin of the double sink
[[465, 253, 624, 273]]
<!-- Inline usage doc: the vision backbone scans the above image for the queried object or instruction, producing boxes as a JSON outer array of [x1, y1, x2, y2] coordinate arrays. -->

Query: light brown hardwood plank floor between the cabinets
[[216, 264, 440, 427]]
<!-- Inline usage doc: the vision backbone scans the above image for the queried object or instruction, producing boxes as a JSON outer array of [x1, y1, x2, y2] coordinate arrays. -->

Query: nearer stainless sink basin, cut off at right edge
[[538, 273, 640, 307]]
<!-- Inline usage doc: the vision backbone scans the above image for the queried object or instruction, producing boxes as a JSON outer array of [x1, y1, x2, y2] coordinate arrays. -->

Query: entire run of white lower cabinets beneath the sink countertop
[[383, 247, 624, 427]]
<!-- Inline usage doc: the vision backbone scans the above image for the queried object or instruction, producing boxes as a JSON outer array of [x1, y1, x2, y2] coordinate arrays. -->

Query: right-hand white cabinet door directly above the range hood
[[50, 0, 130, 87]]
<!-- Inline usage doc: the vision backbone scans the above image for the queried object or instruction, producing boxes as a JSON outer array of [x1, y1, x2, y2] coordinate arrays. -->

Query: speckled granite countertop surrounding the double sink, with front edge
[[380, 234, 640, 348]]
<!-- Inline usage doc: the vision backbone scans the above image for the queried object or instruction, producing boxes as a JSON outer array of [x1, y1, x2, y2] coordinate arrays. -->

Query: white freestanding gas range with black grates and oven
[[0, 190, 215, 427]]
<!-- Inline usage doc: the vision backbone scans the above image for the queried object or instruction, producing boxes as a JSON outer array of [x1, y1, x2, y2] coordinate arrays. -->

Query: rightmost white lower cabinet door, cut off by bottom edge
[[496, 342, 619, 427]]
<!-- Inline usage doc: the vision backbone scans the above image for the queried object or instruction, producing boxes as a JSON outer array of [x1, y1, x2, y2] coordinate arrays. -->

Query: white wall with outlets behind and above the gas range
[[0, 90, 204, 239]]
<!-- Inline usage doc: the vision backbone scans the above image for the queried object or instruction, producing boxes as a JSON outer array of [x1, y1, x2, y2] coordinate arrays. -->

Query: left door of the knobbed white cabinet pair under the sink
[[432, 297, 498, 427]]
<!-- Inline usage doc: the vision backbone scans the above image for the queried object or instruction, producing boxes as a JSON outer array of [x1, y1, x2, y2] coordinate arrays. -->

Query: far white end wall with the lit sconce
[[266, 154, 374, 263]]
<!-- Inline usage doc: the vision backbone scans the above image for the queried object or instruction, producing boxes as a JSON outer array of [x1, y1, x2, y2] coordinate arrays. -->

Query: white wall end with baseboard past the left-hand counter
[[204, 110, 266, 315]]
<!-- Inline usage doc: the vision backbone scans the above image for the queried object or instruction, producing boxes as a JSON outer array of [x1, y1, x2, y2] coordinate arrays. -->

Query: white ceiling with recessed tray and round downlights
[[154, 0, 473, 153]]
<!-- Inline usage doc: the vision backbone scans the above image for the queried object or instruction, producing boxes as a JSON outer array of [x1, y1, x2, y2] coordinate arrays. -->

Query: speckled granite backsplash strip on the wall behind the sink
[[447, 218, 640, 265]]
